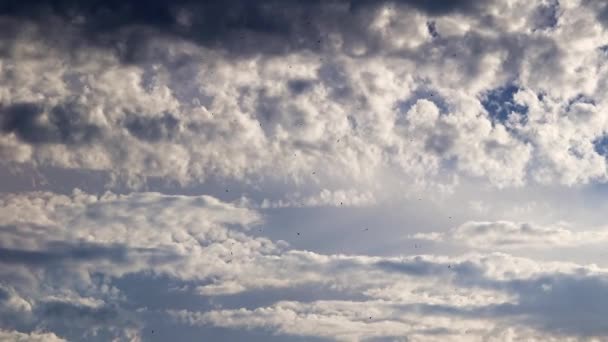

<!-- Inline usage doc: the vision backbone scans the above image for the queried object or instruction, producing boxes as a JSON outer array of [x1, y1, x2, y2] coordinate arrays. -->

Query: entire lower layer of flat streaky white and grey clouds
[[0, 191, 608, 340]]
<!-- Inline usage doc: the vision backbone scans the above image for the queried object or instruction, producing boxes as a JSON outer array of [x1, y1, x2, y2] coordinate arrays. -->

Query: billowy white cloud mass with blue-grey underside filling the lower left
[[0, 191, 267, 340]]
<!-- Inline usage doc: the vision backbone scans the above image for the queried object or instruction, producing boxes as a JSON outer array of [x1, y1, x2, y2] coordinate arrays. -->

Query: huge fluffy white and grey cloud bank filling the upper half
[[0, 1, 606, 195]]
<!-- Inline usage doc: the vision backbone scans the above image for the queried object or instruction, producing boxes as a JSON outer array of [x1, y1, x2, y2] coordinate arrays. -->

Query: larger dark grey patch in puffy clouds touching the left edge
[[0, 102, 101, 145]]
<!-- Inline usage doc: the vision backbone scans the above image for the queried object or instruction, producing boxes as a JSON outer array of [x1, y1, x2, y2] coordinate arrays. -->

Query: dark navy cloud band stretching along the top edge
[[0, 0, 490, 63]]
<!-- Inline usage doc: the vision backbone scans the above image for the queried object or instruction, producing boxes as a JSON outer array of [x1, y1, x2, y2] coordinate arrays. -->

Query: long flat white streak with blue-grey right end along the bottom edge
[[169, 262, 606, 341]]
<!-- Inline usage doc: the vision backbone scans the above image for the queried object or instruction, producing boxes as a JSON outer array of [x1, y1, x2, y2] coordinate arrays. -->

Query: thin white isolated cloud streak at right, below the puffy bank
[[412, 221, 608, 250]]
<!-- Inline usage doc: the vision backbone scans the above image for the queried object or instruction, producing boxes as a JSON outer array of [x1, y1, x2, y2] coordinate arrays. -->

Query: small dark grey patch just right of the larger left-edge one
[[125, 113, 179, 142]]
